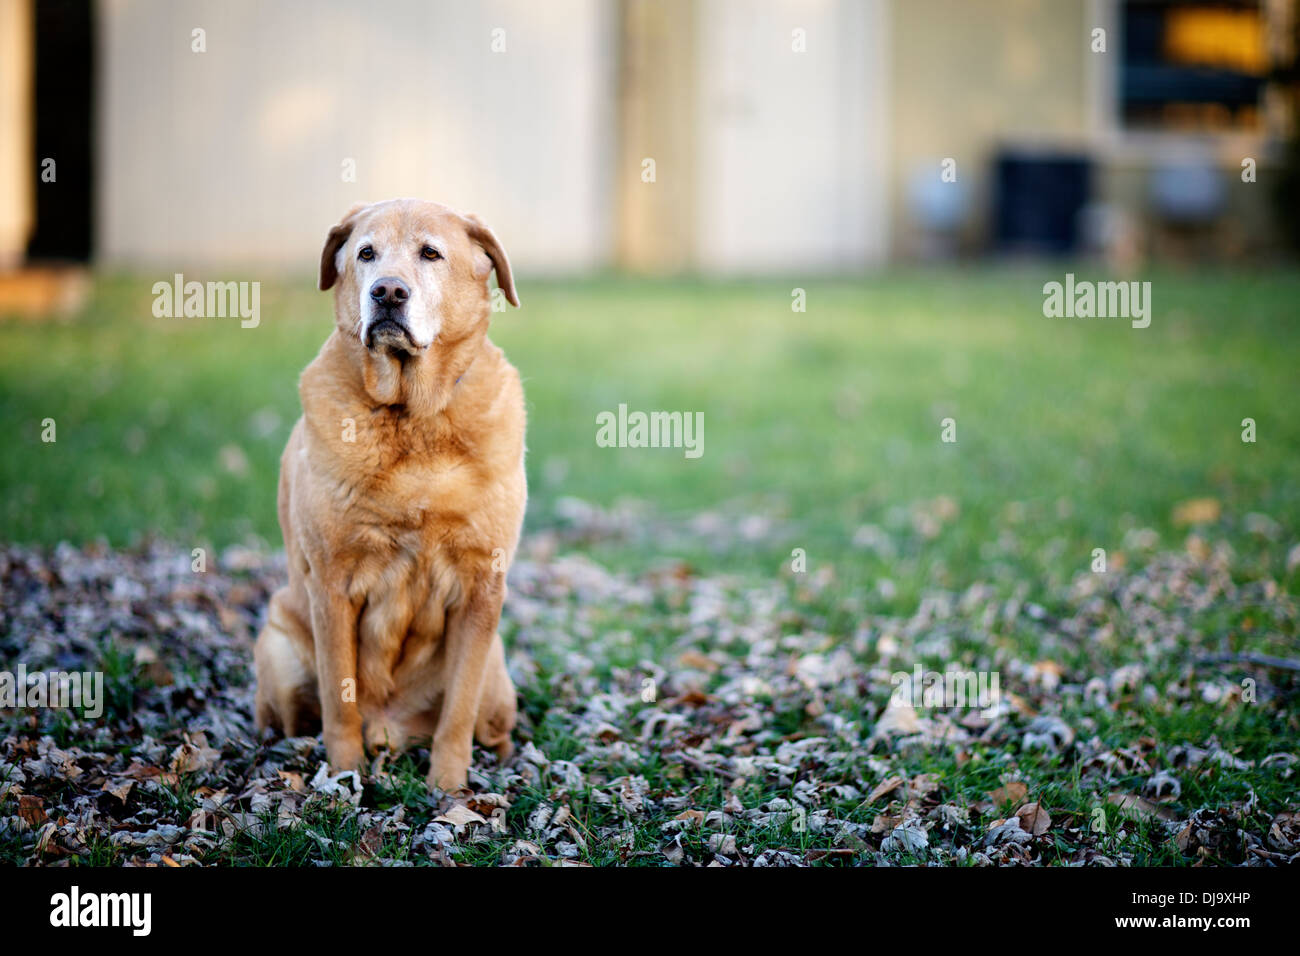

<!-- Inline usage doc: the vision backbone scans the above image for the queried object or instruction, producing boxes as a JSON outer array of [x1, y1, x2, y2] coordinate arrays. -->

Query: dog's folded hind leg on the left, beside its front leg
[[252, 588, 320, 736]]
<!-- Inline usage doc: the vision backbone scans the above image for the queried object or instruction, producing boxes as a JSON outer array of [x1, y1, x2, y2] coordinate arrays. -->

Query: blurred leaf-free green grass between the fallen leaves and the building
[[0, 267, 1300, 597]]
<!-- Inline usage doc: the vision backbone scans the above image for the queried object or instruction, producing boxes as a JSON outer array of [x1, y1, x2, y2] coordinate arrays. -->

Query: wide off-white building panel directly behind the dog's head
[[96, 0, 616, 272]]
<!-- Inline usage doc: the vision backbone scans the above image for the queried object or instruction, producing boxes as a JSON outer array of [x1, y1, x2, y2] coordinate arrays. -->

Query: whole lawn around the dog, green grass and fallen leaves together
[[0, 265, 1300, 865]]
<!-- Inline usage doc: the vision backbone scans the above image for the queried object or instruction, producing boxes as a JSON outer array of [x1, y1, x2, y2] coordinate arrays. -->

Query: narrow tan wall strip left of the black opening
[[0, 0, 39, 268]]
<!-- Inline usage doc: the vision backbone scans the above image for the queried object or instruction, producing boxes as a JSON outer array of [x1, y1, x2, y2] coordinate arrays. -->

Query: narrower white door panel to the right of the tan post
[[696, 0, 889, 274]]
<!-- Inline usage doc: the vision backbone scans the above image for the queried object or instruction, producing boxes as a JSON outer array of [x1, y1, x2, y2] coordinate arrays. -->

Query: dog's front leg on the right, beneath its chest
[[429, 574, 506, 793]]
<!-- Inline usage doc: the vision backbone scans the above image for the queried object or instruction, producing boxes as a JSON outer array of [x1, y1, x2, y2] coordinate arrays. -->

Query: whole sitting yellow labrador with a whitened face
[[254, 199, 527, 791]]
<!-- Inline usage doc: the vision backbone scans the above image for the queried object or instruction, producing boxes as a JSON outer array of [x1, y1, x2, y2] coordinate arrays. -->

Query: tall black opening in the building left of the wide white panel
[[27, 0, 95, 261]]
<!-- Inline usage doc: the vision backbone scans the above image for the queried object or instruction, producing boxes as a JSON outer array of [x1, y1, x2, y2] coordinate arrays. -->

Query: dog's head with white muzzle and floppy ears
[[320, 199, 519, 355]]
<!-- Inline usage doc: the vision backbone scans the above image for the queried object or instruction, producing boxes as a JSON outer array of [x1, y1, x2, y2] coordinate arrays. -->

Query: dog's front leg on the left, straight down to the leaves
[[311, 587, 365, 771]]
